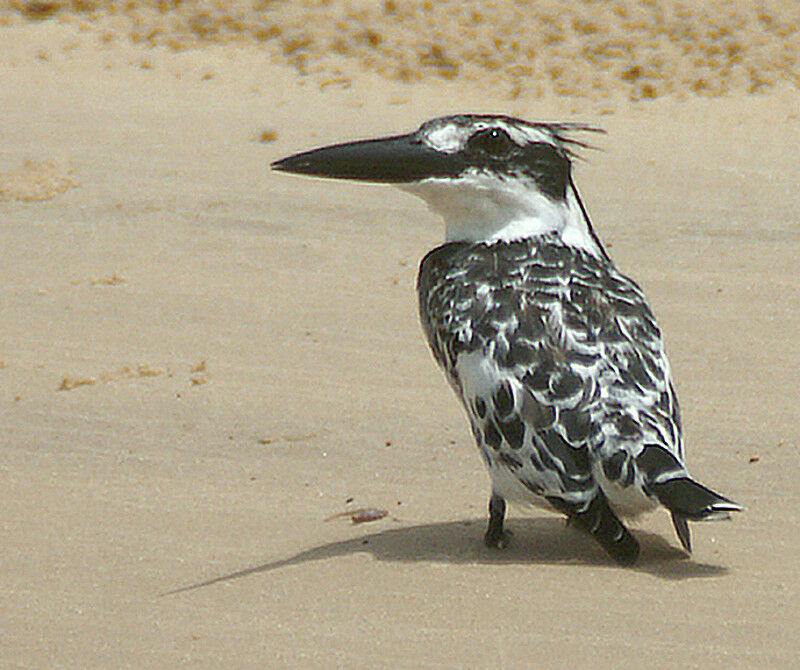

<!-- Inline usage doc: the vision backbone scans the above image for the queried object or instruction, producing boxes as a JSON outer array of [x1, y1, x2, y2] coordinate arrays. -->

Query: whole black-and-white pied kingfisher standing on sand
[[271, 114, 742, 566]]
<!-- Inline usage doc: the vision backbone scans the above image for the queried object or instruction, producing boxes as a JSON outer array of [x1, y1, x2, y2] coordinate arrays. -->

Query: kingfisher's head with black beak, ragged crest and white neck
[[272, 114, 604, 255]]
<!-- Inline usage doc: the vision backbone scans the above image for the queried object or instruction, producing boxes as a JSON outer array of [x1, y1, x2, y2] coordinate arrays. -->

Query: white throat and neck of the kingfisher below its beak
[[398, 172, 602, 256]]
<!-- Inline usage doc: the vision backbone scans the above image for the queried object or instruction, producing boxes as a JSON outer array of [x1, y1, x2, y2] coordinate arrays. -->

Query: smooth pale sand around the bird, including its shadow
[[0, 18, 800, 668]]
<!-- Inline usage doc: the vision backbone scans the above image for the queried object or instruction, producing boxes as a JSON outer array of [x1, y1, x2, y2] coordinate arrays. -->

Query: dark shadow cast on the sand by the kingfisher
[[162, 518, 728, 595]]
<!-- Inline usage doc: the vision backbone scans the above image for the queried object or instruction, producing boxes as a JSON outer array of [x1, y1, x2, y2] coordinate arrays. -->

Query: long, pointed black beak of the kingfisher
[[271, 134, 464, 184]]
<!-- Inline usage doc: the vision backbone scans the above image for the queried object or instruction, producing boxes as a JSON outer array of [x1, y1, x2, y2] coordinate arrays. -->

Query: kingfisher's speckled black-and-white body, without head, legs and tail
[[418, 238, 724, 539]]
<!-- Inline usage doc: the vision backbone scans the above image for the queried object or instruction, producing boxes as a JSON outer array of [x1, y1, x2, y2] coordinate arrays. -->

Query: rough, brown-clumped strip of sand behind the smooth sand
[[0, 0, 800, 99]]
